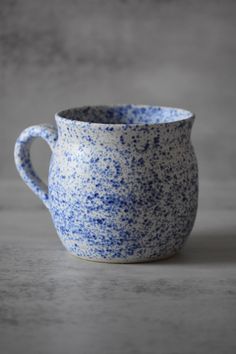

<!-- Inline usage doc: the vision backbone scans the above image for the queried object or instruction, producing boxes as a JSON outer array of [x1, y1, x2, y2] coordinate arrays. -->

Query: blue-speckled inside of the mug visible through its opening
[[57, 105, 193, 124]]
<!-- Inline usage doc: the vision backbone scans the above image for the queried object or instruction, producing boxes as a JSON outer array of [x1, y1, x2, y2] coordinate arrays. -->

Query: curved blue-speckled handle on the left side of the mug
[[14, 124, 57, 208]]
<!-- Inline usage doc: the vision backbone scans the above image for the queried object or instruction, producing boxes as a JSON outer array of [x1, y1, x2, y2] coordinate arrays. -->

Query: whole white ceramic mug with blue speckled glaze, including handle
[[15, 105, 198, 263]]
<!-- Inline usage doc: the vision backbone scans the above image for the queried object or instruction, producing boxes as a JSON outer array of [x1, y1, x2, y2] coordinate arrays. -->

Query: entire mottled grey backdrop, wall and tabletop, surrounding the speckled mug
[[0, 0, 236, 354]]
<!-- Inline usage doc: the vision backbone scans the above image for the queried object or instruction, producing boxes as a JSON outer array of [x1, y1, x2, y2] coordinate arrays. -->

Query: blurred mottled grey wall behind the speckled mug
[[0, 0, 236, 180]]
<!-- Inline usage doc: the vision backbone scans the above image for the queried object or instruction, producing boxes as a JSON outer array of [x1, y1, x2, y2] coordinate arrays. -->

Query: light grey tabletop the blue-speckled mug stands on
[[0, 181, 236, 354]]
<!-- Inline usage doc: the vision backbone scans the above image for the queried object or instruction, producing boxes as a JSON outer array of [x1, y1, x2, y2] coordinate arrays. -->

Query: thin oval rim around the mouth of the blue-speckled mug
[[55, 103, 195, 127]]
